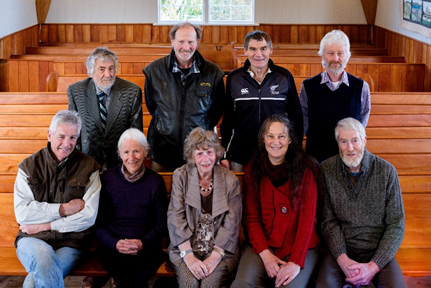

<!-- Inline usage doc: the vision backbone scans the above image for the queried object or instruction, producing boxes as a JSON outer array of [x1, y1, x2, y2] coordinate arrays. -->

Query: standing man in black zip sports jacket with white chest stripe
[[220, 30, 303, 171]]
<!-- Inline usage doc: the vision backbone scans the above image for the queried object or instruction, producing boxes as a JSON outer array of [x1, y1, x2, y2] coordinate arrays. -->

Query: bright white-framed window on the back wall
[[159, 0, 254, 24]]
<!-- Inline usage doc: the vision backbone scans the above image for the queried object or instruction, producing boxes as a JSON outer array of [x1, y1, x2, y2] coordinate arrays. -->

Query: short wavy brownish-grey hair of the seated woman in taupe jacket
[[184, 127, 224, 166]]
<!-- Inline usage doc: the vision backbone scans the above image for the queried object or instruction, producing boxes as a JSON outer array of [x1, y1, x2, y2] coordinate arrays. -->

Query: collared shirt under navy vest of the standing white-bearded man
[[299, 70, 371, 135]]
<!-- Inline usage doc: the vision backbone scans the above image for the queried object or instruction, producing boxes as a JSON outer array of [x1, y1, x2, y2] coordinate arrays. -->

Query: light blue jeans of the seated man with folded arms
[[16, 237, 82, 288]]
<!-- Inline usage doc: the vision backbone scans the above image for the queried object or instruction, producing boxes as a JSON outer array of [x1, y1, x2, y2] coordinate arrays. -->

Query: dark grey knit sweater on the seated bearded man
[[321, 149, 405, 269]]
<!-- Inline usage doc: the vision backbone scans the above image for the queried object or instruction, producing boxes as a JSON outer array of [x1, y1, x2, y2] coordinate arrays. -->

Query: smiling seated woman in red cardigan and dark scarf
[[232, 114, 320, 288]]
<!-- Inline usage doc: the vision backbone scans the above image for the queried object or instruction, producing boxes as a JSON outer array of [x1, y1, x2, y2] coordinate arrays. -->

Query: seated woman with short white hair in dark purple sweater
[[96, 128, 168, 288]]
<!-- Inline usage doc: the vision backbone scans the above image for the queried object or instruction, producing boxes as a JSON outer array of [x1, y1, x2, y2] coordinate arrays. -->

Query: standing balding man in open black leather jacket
[[143, 22, 224, 172]]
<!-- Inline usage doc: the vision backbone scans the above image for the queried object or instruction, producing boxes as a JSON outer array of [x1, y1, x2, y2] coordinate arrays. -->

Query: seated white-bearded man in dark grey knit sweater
[[316, 118, 406, 288]]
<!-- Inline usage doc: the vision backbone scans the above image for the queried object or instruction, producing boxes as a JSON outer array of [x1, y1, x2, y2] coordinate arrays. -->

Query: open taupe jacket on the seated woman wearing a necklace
[[168, 164, 242, 272]]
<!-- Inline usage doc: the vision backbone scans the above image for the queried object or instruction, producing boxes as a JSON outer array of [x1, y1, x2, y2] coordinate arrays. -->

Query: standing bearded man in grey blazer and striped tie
[[67, 47, 143, 171]]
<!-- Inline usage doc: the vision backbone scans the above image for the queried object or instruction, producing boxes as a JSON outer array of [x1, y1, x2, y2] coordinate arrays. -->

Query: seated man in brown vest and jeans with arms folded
[[14, 110, 101, 287]]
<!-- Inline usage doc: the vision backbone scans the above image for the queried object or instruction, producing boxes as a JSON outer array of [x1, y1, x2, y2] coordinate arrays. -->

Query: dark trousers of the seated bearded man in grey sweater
[[316, 248, 406, 288]]
